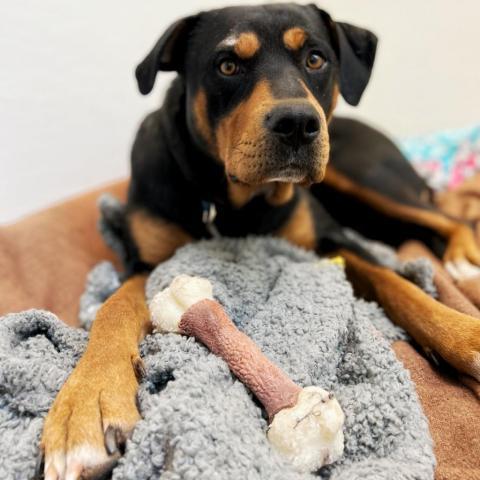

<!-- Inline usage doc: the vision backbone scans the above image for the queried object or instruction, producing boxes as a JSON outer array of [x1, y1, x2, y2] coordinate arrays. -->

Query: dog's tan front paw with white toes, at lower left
[[41, 354, 140, 480]]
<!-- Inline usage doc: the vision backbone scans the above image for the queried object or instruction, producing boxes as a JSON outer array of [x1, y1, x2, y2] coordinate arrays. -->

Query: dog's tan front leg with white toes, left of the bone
[[41, 275, 150, 480]]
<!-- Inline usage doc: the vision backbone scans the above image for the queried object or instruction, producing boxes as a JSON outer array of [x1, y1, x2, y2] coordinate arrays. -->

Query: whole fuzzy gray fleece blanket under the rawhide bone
[[0, 238, 434, 480]]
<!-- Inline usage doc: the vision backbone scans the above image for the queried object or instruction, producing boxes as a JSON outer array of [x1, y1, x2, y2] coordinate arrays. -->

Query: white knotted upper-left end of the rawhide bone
[[150, 275, 213, 333]]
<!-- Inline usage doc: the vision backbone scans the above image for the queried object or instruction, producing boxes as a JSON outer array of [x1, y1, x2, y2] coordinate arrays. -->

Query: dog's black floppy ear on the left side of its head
[[135, 15, 198, 95]]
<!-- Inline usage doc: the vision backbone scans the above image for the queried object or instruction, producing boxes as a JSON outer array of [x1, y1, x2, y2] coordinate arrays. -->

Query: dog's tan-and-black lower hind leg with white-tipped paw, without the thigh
[[315, 167, 480, 279]]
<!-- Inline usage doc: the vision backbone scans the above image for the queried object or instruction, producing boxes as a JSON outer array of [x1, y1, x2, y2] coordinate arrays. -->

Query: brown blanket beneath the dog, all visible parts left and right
[[0, 176, 480, 480]]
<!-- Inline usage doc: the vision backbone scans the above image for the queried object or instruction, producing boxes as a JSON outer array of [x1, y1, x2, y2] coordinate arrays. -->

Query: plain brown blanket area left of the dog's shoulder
[[0, 182, 126, 325]]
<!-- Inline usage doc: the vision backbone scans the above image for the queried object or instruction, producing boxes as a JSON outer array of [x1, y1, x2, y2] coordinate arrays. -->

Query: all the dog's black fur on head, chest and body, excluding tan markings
[[126, 4, 442, 274]]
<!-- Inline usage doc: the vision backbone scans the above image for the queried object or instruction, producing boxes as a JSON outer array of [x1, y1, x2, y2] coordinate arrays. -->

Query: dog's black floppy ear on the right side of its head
[[315, 6, 378, 105]]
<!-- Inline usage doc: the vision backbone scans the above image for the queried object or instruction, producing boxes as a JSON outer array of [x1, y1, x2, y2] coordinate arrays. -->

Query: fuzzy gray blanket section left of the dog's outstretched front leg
[[0, 310, 88, 480]]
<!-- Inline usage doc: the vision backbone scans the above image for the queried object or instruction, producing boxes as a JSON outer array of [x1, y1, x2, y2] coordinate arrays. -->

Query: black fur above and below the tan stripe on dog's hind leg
[[311, 118, 446, 256]]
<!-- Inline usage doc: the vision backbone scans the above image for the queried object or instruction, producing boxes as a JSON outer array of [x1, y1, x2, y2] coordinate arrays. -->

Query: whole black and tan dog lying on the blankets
[[42, 4, 480, 480]]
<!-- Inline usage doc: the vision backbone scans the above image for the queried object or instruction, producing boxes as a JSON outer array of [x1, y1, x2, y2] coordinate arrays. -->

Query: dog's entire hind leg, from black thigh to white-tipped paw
[[311, 118, 480, 279]]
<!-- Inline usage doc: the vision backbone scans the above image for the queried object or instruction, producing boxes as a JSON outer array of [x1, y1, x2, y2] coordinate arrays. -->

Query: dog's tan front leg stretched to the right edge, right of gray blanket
[[341, 250, 480, 381]]
